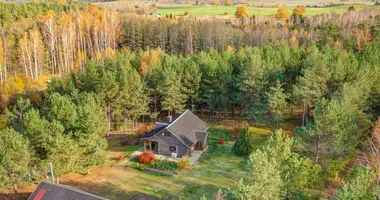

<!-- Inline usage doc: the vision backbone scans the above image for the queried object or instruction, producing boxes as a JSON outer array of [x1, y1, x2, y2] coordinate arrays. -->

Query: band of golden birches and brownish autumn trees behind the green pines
[[0, 1, 379, 88]]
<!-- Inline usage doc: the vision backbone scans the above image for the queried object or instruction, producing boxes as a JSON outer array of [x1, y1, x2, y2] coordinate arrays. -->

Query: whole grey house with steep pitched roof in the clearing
[[141, 110, 209, 157]]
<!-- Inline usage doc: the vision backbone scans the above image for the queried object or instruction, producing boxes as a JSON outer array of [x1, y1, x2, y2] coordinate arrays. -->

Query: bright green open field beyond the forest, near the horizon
[[158, 4, 380, 16]]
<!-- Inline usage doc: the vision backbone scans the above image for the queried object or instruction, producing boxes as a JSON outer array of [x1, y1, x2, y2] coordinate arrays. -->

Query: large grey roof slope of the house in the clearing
[[166, 110, 208, 147]]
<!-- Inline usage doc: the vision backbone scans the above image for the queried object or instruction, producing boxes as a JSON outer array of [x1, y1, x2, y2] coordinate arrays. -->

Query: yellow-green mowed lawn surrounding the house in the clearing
[[53, 119, 299, 200]]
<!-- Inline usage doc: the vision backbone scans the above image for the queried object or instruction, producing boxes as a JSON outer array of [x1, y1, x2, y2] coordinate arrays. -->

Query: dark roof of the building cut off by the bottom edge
[[28, 182, 108, 200]]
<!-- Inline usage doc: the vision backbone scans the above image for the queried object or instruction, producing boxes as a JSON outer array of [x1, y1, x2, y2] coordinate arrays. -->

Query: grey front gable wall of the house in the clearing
[[149, 131, 188, 157]]
